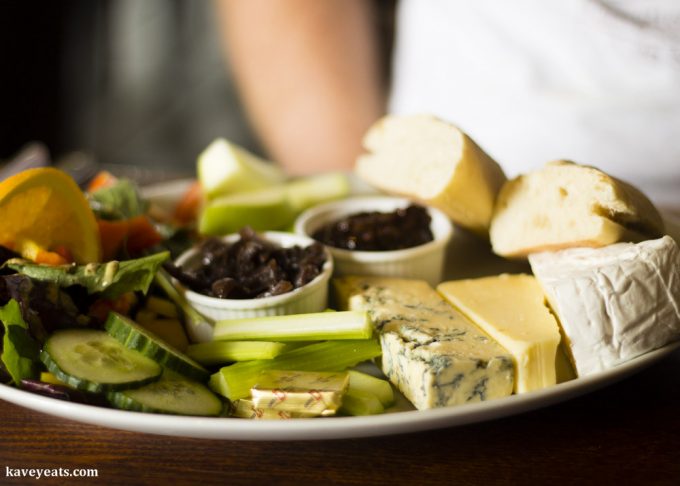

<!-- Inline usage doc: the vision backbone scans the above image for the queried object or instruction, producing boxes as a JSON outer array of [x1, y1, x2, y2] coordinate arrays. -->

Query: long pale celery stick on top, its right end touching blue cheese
[[213, 311, 373, 341]]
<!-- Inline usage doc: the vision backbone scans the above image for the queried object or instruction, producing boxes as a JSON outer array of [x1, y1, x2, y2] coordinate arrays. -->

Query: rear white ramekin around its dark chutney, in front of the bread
[[295, 196, 453, 286]]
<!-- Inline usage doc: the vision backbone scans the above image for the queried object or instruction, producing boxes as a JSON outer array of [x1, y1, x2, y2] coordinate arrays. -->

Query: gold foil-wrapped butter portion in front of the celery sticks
[[250, 371, 349, 416]]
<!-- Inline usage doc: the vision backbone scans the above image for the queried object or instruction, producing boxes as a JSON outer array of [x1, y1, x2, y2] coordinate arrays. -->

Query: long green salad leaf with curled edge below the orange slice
[[5, 251, 170, 299]]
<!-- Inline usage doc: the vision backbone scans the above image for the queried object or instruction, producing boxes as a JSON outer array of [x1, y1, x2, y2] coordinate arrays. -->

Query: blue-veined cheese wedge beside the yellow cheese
[[334, 277, 515, 410]]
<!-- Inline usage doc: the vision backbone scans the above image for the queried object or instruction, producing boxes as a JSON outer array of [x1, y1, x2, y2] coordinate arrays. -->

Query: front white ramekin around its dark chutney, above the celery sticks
[[175, 231, 333, 340]]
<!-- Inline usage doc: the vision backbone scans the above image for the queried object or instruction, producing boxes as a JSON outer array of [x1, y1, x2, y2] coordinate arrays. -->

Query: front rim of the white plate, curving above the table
[[0, 343, 680, 440]]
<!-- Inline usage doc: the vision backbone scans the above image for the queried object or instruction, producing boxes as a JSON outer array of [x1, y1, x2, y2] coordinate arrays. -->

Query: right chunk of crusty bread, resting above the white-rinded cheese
[[490, 160, 664, 257]]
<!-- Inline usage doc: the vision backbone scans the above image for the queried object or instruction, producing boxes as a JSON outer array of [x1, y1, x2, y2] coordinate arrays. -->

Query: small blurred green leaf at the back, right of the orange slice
[[90, 179, 147, 219]]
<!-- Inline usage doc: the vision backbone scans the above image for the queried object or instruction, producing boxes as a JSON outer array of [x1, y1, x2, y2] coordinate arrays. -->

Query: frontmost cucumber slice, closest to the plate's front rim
[[106, 369, 223, 416]]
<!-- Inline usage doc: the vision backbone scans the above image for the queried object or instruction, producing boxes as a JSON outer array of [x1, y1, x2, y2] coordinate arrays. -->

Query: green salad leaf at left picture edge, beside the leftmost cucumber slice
[[0, 299, 40, 384]]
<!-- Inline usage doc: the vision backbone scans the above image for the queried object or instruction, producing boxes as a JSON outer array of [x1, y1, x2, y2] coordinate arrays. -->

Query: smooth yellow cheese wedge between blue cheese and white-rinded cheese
[[437, 274, 560, 393]]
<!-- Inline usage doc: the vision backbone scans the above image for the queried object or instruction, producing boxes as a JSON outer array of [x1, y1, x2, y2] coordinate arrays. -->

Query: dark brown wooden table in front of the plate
[[0, 352, 680, 485]]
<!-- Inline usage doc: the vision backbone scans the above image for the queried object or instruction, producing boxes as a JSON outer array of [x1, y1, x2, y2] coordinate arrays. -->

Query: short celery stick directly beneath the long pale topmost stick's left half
[[187, 341, 287, 365]]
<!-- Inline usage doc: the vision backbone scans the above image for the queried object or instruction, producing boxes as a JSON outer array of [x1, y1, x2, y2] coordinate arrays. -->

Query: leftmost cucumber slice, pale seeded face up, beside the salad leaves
[[40, 329, 163, 393]]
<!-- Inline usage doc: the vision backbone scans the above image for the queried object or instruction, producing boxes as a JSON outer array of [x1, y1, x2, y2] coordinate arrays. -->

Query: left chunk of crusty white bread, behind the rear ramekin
[[355, 115, 506, 237]]
